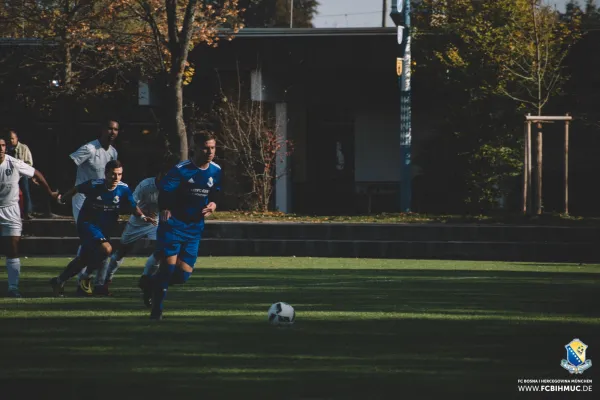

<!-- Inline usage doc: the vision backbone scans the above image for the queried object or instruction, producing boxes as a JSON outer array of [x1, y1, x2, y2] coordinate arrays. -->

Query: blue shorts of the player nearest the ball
[[156, 218, 204, 268]]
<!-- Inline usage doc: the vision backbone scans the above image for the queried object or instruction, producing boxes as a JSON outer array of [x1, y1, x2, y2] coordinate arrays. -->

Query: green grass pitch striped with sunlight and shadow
[[0, 258, 600, 400]]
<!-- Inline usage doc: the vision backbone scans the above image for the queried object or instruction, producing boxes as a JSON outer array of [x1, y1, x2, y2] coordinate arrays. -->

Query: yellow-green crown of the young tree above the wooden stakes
[[428, 0, 581, 115]]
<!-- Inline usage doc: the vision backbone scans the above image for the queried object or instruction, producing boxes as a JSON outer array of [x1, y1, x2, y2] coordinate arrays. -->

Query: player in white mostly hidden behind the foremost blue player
[[95, 157, 179, 285]]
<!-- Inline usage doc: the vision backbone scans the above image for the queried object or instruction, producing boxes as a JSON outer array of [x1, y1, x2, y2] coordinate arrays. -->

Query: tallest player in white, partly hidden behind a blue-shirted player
[[69, 120, 119, 294]]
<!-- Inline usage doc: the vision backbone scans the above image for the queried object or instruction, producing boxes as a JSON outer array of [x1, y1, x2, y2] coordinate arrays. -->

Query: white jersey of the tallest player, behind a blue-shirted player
[[70, 139, 117, 185]]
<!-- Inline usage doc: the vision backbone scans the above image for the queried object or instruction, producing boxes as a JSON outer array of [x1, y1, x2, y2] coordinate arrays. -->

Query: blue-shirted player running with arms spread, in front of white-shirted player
[[50, 160, 153, 297]]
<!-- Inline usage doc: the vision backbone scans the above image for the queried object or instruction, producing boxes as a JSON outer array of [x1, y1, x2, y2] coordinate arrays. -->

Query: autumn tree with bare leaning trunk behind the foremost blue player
[[111, 0, 243, 160]]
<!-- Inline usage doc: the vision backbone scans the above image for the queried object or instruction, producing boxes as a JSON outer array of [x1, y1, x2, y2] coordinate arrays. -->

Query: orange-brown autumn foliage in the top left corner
[[2, 0, 144, 101]]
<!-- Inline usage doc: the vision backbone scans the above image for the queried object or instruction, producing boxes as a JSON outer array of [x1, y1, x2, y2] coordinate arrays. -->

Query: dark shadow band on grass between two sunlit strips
[[0, 267, 600, 317]]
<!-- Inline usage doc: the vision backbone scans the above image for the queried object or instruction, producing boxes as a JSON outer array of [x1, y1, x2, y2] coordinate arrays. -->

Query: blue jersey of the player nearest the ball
[[158, 160, 221, 226]]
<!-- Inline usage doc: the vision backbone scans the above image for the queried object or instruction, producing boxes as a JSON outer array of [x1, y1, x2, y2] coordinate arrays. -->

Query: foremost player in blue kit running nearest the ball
[[142, 134, 221, 320]]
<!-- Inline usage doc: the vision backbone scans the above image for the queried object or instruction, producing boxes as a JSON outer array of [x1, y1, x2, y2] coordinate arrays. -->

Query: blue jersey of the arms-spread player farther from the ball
[[77, 179, 136, 233]]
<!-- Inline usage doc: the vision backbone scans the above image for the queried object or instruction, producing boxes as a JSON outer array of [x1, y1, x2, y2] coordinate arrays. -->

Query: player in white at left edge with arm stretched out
[[0, 134, 58, 298]]
